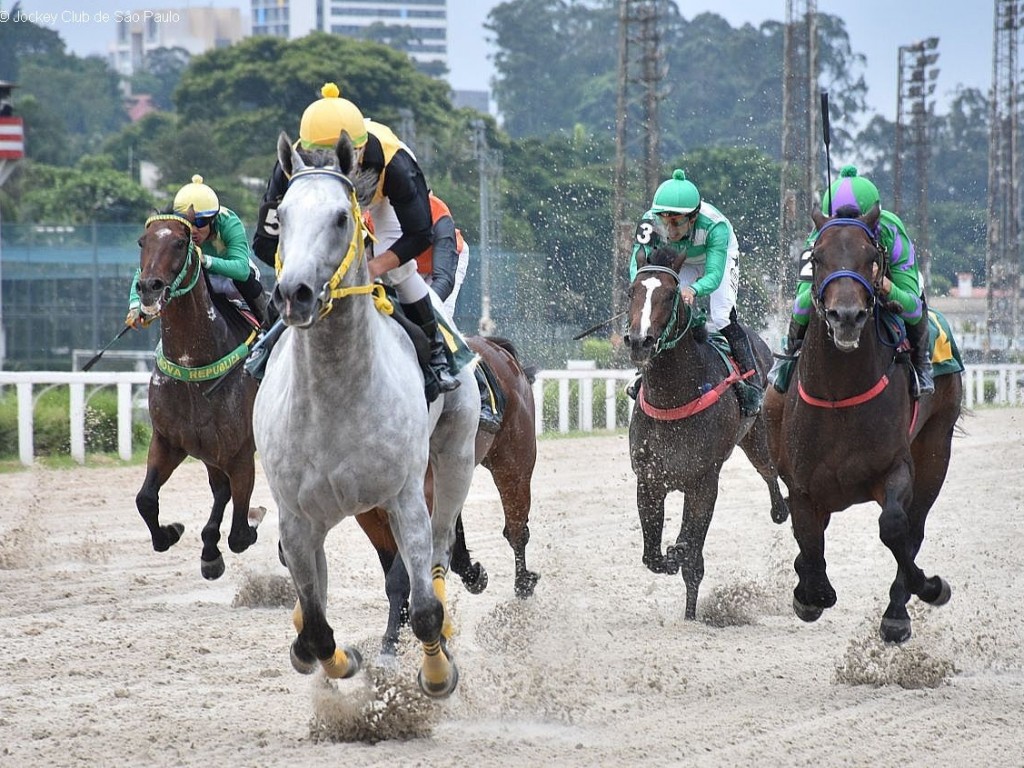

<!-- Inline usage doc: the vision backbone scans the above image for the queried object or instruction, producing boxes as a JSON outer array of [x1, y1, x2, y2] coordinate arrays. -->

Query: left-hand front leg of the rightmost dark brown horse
[[790, 494, 836, 622]]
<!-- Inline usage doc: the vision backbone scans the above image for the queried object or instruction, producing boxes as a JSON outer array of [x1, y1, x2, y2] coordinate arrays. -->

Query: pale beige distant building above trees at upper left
[[108, 7, 248, 76]]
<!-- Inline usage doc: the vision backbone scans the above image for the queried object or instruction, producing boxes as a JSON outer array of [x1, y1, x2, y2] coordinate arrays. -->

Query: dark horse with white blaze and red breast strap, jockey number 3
[[625, 248, 788, 618]]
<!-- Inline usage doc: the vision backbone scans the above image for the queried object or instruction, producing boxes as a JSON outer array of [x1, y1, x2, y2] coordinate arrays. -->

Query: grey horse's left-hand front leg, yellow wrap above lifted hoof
[[278, 514, 362, 678]]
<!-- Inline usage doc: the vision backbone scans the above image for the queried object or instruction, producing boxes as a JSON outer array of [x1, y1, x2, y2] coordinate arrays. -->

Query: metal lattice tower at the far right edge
[[984, 0, 1024, 357]]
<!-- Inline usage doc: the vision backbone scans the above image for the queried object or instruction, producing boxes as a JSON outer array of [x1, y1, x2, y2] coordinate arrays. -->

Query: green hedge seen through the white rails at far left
[[0, 386, 150, 459]]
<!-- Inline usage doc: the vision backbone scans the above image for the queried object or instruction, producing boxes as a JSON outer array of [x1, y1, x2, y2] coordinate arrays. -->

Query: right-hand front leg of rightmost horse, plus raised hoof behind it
[[879, 464, 951, 643]]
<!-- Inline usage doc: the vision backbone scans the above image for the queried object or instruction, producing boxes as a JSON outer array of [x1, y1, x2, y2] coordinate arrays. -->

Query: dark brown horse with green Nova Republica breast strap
[[135, 214, 262, 579]]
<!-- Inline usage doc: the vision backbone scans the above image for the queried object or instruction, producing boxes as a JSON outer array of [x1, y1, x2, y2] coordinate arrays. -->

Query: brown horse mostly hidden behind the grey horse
[[355, 336, 540, 657]]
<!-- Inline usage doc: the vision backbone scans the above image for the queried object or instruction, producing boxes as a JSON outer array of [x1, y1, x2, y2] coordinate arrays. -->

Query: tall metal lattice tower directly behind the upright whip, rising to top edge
[[776, 0, 821, 309]]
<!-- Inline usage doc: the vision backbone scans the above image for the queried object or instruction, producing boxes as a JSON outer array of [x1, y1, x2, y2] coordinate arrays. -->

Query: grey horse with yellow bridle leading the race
[[253, 133, 480, 697]]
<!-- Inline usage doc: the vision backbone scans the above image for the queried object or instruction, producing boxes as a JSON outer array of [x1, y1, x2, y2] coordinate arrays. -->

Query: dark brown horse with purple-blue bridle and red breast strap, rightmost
[[766, 206, 963, 643]]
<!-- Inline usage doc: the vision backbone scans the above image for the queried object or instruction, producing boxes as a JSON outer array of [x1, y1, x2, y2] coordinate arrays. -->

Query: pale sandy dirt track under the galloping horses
[[0, 409, 1024, 768]]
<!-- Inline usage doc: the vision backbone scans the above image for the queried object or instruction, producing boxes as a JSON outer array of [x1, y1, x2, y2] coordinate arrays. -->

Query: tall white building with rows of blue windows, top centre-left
[[252, 0, 447, 69]]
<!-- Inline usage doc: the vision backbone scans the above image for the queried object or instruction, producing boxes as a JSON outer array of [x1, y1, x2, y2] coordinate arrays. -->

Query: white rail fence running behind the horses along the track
[[0, 365, 1024, 466]]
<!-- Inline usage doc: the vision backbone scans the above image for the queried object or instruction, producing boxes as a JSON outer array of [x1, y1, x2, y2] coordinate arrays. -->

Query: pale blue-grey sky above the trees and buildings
[[14, 0, 994, 120]]
